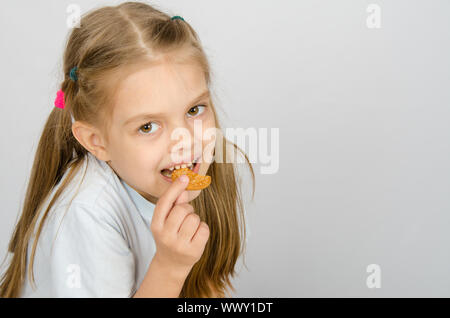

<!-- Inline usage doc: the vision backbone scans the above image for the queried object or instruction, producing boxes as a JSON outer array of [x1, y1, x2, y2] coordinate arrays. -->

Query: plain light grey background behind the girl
[[0, 0, 450, 297]]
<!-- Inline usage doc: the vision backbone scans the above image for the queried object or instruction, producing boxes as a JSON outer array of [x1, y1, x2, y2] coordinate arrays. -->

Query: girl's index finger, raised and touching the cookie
[[152, 176, 189, 227]]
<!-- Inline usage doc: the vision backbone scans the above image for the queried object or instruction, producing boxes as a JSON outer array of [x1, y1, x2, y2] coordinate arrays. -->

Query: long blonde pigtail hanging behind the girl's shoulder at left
[[0, 85, 84, 297]]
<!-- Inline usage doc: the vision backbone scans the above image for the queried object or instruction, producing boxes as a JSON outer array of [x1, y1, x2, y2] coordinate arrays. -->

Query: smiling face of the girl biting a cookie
[[106, 62, 215, 203]]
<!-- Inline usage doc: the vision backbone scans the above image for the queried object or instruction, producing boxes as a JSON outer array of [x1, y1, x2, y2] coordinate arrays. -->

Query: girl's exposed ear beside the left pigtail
[[72, 121, 110, 161]]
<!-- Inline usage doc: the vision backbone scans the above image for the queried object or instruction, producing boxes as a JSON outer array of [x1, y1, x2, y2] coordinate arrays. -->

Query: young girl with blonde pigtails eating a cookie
[[0, 2, 255, 297]]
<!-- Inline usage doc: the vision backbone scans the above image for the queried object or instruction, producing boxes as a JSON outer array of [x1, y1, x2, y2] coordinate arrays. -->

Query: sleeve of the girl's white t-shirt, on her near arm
[[49, 203, 136, 297]]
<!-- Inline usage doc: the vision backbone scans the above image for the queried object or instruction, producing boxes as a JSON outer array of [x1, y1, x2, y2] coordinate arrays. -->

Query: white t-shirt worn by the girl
[[21, 153, 156, 297]]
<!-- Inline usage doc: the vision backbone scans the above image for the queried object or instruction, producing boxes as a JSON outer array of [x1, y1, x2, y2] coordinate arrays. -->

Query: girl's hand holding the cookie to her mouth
[[150, 176, 209, 275]]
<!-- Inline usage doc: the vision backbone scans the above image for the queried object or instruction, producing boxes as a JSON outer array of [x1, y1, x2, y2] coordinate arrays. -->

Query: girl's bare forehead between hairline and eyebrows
[[113, 62, 207, 122]]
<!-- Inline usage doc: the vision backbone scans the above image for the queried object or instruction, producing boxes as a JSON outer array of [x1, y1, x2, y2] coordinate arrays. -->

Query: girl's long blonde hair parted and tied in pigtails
[[0, 2, 255, 297]]
